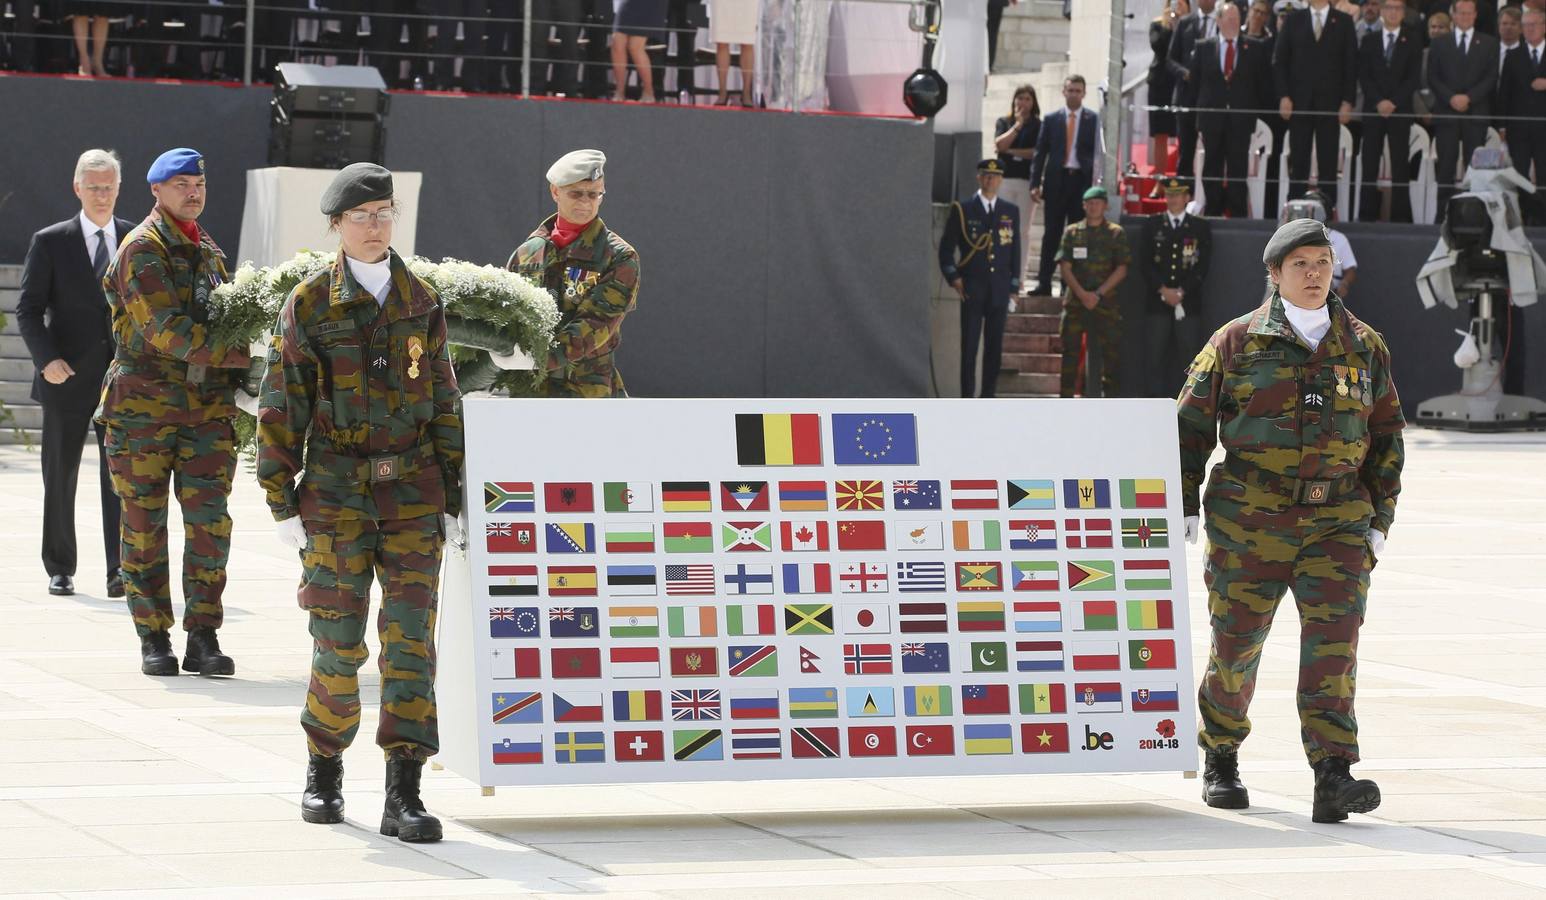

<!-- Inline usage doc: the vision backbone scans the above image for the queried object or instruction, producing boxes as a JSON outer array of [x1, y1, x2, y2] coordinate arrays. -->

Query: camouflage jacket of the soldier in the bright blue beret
[[100, 207, 250, 425]]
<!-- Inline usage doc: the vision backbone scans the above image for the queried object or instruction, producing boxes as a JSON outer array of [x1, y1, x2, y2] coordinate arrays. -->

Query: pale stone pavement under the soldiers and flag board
[[0, 430, 1546, 900]]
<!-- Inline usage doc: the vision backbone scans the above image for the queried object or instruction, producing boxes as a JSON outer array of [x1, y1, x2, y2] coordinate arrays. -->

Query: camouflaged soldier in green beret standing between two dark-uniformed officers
[[1057, 186, 1130, 397]]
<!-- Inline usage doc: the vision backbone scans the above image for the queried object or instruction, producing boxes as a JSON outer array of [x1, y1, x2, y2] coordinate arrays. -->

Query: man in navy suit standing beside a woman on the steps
[[1031, 74, 1105, 297]]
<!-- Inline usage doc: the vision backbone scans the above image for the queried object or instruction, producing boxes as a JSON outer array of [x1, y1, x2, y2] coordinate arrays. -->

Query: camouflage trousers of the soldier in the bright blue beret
[[104, 419, 237, 637]]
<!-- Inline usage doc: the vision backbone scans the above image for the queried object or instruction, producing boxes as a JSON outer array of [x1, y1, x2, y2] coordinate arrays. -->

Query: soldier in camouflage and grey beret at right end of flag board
[[1177, 220, 1405, 821]]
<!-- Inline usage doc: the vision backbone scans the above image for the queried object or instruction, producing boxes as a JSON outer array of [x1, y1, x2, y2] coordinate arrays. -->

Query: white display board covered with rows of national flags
[[438, 399, 1197, 787]]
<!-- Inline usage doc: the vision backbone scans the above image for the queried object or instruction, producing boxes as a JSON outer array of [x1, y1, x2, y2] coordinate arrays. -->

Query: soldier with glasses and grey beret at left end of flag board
[[258, 162, 462, 841]]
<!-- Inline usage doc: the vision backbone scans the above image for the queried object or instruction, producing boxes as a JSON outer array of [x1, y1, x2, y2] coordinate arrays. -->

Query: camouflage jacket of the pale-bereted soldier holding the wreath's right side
[[506, 215, 638, 397]]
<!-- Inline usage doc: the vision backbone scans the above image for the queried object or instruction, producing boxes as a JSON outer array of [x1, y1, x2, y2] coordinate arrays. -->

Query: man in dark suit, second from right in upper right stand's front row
[[1429, 0, 1498, 221]]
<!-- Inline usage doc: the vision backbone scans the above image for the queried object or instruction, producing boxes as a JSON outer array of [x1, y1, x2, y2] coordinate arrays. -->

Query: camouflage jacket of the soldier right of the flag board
[[1177, 292, 1407, 534]]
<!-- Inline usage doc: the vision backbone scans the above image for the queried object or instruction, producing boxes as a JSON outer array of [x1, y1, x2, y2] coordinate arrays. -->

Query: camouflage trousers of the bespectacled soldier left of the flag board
[[300, 515, 444, 759]]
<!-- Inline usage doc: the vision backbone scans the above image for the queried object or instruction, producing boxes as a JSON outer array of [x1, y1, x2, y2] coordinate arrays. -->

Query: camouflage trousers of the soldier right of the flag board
[[1197, 470, 1374, 765]]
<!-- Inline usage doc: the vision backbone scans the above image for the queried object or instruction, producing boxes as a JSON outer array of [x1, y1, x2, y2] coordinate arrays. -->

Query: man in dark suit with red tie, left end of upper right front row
[[1192, 3, 1271, 218]]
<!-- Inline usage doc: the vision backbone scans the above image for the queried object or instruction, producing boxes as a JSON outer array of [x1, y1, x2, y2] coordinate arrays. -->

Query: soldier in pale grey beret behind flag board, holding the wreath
[[507, 150, 638, 397]]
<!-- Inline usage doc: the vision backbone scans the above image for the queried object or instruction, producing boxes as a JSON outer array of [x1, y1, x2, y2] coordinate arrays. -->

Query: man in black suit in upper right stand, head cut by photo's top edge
[[1272, 0, 1357, 196]]
